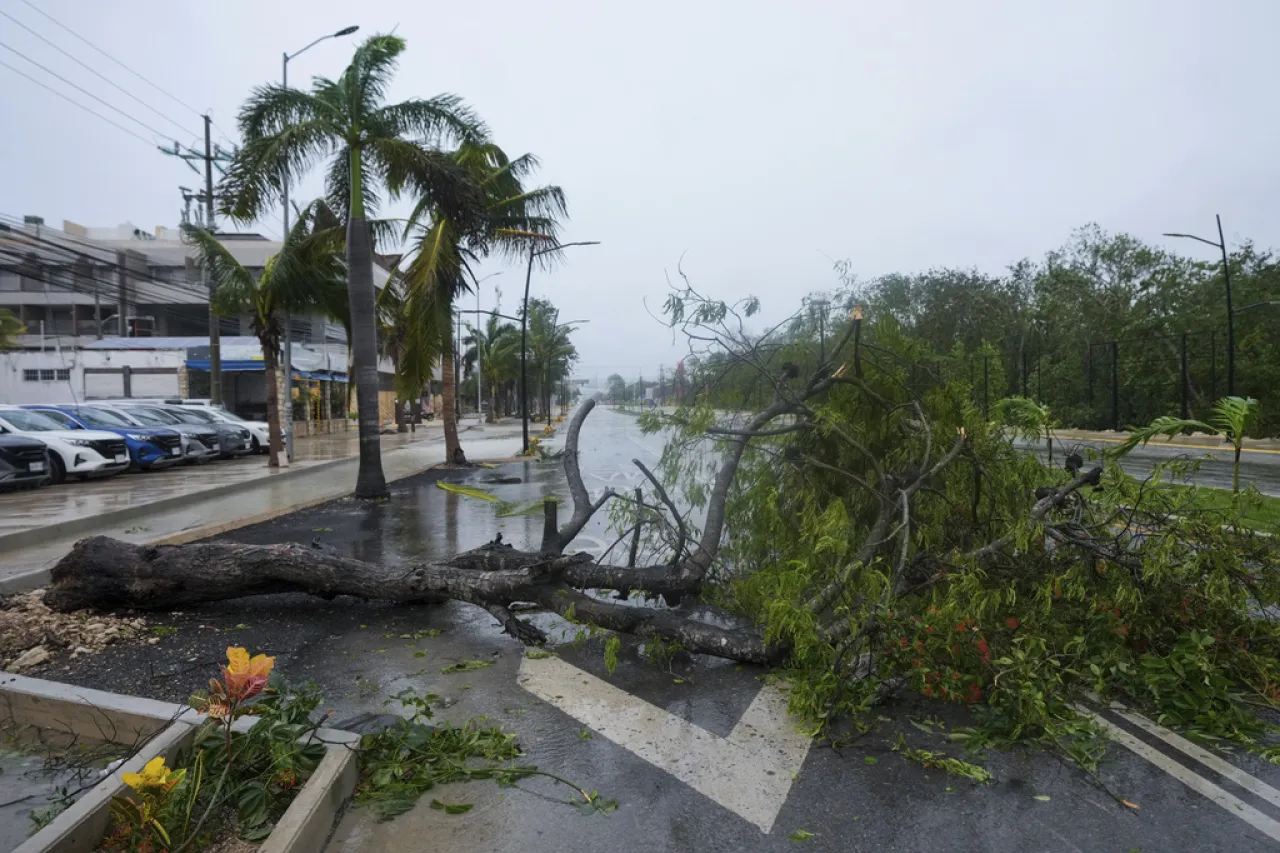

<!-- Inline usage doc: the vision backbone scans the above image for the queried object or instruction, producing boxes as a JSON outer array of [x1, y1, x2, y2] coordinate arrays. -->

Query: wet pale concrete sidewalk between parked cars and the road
[[0, 425, 521, 592]]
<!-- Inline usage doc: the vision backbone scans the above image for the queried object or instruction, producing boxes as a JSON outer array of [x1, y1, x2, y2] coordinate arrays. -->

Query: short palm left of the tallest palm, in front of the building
[[183, 201, 349, 467]]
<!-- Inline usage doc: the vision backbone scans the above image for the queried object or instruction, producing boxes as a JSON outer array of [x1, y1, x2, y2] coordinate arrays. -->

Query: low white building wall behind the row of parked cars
[[0, 347, 187, 403]]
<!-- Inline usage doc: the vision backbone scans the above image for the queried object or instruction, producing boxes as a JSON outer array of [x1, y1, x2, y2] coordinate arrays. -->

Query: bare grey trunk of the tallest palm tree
[[347, 146, 389, 500]]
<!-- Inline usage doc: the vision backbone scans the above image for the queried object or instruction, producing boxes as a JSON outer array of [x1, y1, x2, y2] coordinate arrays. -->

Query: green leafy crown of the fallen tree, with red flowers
[[644, 275, 1280, 765]]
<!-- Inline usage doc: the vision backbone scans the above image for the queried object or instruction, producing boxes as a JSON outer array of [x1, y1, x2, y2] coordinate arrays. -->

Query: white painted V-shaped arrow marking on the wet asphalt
[[518, 657, 810, 833]]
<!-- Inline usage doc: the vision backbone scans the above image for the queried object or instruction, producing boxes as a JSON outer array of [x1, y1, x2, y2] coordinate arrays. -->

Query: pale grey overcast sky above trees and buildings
[[0, 0, 1280, 378]]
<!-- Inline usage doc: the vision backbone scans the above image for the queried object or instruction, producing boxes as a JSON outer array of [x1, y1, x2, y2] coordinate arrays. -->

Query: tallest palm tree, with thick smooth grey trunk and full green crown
[[223, 36, 486, 498]]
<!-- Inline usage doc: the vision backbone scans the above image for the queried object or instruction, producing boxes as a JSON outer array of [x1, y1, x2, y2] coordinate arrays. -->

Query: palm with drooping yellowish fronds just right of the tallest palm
[[404, 142, 567, 464]]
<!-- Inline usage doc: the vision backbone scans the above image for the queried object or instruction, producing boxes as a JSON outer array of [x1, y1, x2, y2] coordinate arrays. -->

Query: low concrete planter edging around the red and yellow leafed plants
[[0, 674, 360, 853]]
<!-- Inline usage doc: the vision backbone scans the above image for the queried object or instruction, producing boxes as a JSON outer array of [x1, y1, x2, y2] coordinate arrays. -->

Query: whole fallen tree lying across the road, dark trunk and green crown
[[45, 280, 1280, 758]]
